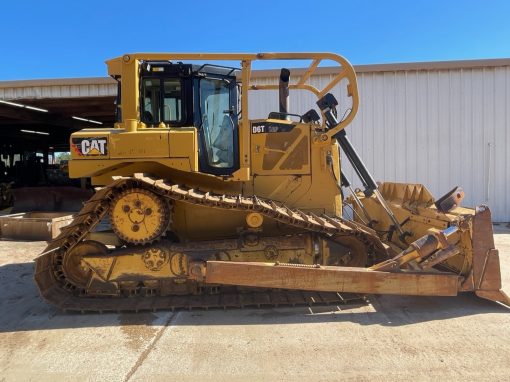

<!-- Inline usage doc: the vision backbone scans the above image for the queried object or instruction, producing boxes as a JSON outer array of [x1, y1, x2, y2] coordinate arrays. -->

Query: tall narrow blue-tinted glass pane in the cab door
[[200, 78, 235, 168]]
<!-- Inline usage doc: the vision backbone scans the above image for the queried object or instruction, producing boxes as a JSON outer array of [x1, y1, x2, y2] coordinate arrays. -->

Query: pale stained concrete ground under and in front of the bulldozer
[[0, 225, 510, 381]]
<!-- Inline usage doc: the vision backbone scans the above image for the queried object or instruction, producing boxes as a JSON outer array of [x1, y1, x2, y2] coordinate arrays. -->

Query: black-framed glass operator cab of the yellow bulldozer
[[140, 61, 239, 175]]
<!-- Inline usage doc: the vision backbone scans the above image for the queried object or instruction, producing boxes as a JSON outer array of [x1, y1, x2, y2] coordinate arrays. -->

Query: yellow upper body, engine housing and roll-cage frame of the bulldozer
[[69, 53, 359, 239]]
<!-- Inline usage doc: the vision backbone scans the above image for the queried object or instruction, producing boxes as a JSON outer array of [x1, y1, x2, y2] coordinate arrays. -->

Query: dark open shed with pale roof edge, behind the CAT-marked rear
[[0, 78, 117, 187]]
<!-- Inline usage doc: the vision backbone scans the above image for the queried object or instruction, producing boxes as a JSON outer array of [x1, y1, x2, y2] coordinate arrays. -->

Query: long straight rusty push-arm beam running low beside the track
[[198, 261, 459, 296]]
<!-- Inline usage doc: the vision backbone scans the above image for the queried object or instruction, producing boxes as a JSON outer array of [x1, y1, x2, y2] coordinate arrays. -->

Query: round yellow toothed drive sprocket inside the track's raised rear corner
[[110, 188, 170, 244]]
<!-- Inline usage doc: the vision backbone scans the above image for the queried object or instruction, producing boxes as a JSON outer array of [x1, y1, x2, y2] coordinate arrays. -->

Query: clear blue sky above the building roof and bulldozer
[[0, 0, 510, 80]]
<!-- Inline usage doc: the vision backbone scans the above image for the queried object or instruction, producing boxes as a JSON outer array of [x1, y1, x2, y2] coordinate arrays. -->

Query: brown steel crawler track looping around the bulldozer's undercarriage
[[35, 174, 385, 312]]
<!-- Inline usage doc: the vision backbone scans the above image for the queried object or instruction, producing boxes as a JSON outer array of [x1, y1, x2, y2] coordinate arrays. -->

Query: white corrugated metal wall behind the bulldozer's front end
[[250, 66, 510, 221]]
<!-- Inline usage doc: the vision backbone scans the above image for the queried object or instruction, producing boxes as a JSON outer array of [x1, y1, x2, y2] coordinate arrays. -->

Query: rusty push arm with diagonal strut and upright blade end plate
[[190, 207, 510, 306]]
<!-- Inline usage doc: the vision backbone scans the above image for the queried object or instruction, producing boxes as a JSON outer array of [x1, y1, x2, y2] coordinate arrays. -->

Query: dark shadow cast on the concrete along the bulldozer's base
[[0, 262, 510, 333]]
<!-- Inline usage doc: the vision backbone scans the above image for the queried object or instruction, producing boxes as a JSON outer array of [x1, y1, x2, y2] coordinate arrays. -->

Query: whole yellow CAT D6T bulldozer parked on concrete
[[35, 53, 510, 312]]
